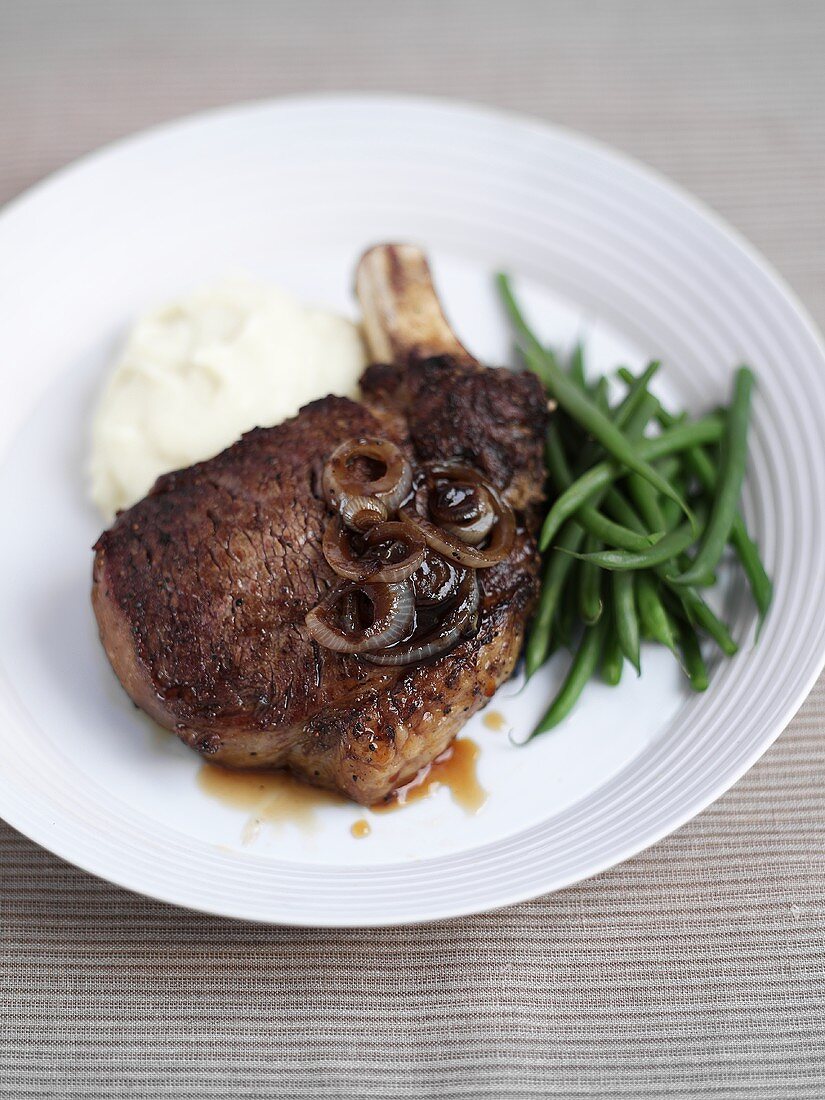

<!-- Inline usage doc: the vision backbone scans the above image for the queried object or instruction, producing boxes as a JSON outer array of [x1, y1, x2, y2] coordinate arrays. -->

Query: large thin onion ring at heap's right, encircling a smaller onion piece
[[398, 465, 516, 569]]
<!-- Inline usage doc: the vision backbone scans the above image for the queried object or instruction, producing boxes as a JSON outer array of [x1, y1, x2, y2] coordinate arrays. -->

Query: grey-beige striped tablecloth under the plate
[[0, 0, 825, 1100]]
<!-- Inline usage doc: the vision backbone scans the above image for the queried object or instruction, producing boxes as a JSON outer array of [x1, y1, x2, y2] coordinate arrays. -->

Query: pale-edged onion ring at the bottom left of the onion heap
[[306, 581, 416, 655]]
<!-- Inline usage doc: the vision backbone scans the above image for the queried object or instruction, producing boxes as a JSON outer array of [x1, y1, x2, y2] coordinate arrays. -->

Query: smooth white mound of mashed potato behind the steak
[[89, 277, 365, 521]]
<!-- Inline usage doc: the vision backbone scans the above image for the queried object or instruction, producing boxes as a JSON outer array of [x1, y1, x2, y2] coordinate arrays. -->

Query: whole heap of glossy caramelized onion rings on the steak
[[306, 448, 516, 666]]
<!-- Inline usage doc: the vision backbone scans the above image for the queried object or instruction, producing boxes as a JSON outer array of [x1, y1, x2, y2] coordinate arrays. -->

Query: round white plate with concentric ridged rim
[[0, 96, 825, 925]]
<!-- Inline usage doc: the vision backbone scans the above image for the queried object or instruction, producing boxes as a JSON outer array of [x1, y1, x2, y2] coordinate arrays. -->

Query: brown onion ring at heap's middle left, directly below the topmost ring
[[322, 516, 426, 584]]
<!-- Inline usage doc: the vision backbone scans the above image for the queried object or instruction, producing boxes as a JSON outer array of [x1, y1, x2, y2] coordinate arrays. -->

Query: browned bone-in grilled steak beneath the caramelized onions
[[92, 245, 547, 804]]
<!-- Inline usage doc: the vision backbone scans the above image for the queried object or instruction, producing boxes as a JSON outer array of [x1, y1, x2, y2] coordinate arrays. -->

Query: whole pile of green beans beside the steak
[[496, 274, 772, 736]]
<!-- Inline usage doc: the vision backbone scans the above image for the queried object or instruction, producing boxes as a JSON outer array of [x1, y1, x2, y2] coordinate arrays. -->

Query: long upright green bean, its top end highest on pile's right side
[[678, 366, 754, 584]]
